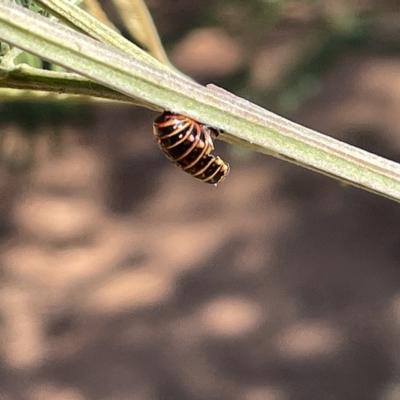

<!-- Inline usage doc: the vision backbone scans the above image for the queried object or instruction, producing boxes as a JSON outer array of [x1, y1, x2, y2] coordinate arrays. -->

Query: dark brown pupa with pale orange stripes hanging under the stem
[[153, 111, 229, 185]]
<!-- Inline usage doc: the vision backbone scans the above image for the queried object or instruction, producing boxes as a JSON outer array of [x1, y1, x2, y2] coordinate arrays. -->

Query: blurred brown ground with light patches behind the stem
[[0, 0, 400, 400]]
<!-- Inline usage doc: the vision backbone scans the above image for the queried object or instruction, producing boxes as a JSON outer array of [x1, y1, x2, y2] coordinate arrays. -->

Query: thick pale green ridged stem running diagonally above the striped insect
[[0, 0, 400, 201]]
